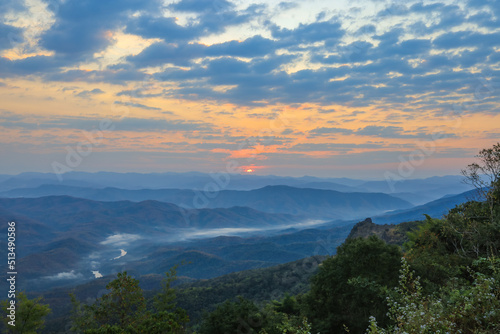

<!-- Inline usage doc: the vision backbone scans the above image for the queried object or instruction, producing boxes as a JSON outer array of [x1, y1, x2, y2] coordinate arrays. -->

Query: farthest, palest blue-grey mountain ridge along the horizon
[[0, 172, 471, 200]]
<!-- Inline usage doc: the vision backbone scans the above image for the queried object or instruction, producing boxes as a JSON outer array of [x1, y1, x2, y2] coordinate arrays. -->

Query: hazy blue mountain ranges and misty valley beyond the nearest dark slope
[[0, 173, 476, 290]]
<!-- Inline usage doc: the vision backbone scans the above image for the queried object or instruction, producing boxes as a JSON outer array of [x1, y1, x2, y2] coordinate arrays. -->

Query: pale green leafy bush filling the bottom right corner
[[367, 258, 500, 334]]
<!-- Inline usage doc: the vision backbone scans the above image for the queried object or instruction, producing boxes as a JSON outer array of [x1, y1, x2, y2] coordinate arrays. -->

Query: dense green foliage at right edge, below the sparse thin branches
[[405, 201, 500, 292]]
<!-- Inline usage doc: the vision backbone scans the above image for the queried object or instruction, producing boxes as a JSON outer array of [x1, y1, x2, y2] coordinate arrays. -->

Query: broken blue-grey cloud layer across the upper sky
[[0, 0, 500, 111]]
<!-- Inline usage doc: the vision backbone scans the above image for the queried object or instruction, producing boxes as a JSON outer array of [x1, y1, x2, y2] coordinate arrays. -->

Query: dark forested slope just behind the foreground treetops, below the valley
[[39, 256, 326, 333]]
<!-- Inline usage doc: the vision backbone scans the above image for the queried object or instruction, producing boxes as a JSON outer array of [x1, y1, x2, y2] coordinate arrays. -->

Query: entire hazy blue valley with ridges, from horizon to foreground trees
[[0, 173, 484, 330]]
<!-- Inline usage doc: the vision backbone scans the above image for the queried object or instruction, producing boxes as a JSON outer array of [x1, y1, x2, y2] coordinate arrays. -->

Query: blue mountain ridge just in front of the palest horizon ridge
[[0, 185, 412, 220]]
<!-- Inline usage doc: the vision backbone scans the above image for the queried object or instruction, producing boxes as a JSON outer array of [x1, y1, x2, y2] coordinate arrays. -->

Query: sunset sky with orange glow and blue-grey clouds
[[0, 0, 500, 179]]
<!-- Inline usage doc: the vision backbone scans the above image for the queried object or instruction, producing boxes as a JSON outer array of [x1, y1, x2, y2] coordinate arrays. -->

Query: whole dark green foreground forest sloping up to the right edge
[[2, 144, 500, 334]]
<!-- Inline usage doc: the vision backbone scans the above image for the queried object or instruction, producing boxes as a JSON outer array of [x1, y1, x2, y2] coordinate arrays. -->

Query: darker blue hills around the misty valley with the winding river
[[0, 196, 350, 290]]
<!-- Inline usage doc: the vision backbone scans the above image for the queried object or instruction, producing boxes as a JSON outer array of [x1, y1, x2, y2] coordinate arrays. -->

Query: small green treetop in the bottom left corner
[[1, 292, 51, 334]]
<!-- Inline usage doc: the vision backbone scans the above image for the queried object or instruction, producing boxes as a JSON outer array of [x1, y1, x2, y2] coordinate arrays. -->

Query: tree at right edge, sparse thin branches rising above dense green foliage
[[406, 144, 500, 292]]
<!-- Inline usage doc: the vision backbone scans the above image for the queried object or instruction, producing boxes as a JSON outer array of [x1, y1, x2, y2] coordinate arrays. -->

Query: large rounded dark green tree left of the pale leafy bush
[[305, 236, 402, 333]]
